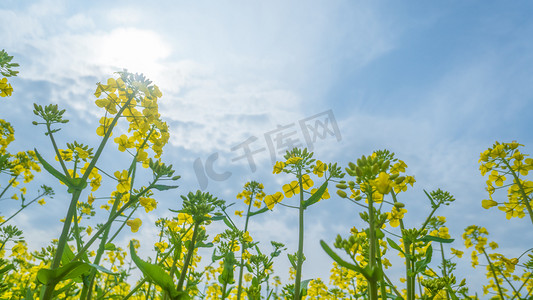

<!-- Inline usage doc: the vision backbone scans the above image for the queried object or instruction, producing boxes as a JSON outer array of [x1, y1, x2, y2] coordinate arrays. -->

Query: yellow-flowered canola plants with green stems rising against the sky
[[0, 50, 533, 300]]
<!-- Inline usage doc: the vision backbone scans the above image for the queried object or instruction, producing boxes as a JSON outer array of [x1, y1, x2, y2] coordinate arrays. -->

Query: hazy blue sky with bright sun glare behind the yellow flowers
[[0, 0, 533, 291]]
